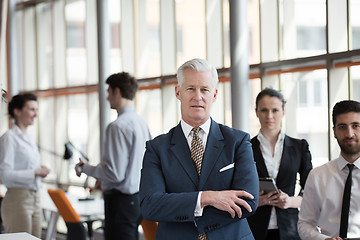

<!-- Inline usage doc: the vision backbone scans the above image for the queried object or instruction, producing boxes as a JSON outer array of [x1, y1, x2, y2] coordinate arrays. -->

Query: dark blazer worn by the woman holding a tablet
[[248, 135, 312, 240]]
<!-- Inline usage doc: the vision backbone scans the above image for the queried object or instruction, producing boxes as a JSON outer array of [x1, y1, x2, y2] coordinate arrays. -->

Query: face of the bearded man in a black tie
[[333, 112, 360, 160]]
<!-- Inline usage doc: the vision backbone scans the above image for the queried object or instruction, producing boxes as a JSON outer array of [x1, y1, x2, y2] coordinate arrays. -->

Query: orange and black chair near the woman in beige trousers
[[48, 189, 86, 240]]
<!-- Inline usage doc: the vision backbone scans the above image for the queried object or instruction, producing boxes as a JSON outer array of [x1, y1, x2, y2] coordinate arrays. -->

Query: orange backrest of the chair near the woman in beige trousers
[[48, 189, 81, 223]]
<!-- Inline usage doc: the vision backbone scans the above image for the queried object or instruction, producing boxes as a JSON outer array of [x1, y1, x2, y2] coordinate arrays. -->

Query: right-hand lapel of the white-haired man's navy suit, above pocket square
[[199, 120, 224, 189]]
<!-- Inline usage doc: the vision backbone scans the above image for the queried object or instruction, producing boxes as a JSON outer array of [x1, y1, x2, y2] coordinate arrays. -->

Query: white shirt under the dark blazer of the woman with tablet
[[257, 131, 285, 229]]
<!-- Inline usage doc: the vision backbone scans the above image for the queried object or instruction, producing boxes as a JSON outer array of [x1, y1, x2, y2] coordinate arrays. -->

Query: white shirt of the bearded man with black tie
[[298, 155, 360, 240]]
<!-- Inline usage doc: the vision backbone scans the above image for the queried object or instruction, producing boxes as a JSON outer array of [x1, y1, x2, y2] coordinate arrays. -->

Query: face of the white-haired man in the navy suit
[[175, 69, 217, 127]]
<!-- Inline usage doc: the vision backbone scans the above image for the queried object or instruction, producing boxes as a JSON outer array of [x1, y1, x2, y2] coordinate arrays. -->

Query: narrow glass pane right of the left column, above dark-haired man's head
[[108, 0, 122, 73]]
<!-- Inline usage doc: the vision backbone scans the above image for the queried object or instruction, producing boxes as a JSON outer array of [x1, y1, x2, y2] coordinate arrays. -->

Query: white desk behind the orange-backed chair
[[41, 189, 104, 240]]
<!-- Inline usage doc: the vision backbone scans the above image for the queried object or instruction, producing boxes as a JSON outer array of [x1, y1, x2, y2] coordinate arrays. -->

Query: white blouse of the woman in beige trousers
[[0, 124, 41, 190]]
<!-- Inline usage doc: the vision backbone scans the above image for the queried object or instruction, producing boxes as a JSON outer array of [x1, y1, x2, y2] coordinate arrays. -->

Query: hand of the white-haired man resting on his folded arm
[[201, 190, 254, 218]]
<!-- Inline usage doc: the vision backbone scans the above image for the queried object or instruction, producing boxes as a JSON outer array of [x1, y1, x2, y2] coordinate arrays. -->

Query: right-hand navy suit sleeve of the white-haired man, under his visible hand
[[196, 134, 259, 233]]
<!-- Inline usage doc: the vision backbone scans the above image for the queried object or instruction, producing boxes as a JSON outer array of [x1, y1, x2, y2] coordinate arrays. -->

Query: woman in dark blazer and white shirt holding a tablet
[[248, 88, 312, 240]]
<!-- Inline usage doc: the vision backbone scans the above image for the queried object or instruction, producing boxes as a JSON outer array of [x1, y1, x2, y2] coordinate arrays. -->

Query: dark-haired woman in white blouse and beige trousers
[[0, 93, 49, 238]]
